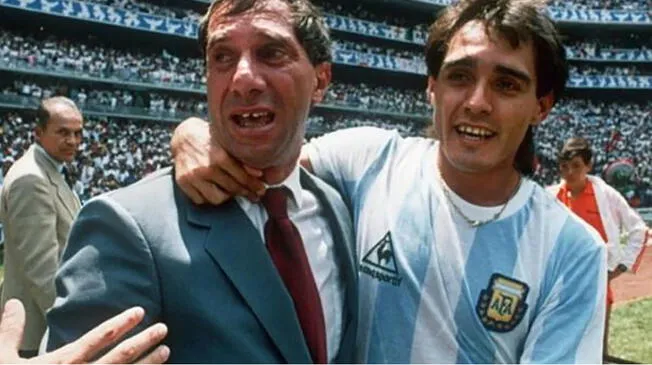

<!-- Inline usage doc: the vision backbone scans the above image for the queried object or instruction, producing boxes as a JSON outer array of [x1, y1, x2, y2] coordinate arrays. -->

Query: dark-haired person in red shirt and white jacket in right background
[[548, 138, 647, 355]]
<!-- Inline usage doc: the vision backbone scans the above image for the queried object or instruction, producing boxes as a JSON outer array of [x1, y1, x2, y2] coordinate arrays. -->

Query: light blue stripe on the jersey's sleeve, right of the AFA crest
[[525, 217, 606, 363]]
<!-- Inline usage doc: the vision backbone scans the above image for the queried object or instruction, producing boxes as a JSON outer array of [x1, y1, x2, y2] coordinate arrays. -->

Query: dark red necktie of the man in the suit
[[262, 188, 327, 364]]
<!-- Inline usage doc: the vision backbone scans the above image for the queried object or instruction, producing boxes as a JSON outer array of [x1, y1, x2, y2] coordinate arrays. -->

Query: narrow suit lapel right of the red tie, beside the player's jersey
[[301, 169, 358, 363]]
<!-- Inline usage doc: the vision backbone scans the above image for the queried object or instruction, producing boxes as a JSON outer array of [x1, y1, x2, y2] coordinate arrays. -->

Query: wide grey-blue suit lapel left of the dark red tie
[[188, 200, 312, 363]]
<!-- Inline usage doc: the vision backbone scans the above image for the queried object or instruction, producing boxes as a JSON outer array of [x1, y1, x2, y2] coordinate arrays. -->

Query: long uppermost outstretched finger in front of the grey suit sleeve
[[45, 307, 145, 363]]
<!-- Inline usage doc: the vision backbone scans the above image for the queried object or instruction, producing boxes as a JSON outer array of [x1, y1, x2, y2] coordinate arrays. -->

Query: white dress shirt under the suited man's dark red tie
[[235, 166, 344, 362]]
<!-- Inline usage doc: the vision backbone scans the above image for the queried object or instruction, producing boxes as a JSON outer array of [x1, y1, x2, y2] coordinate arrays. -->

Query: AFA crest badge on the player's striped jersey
[[476, 273, 530, 332]]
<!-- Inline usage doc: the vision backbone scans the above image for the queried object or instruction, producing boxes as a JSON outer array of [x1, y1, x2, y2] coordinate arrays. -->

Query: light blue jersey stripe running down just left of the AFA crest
[[455, 198, 533, 363]]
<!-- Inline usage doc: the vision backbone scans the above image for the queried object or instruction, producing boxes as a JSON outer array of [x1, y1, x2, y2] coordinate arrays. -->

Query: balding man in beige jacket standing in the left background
[[0, 97, 83, 357]]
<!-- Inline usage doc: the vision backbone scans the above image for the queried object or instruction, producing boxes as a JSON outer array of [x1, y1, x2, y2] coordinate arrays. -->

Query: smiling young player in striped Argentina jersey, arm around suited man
[[173, 0, 607, 363]]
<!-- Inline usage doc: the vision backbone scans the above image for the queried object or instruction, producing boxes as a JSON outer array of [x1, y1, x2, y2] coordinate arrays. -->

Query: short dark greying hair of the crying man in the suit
[[198, 0, 332, 66]]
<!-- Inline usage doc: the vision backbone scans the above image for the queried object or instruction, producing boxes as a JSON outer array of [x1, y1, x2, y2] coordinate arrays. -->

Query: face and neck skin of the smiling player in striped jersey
[[428, 21, 552, 206]]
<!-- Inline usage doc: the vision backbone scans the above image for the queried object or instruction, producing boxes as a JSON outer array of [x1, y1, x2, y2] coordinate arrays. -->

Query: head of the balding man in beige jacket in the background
[[35, 103, 84, 162]]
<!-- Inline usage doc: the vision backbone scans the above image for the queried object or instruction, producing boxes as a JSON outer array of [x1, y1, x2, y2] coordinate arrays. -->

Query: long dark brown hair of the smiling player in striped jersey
[[425, 0, 568, 176]]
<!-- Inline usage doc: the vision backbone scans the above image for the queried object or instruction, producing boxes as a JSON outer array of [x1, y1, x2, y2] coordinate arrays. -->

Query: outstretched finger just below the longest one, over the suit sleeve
[[97, 323, 169, 364]]
